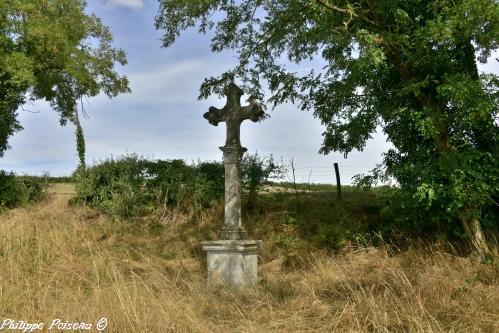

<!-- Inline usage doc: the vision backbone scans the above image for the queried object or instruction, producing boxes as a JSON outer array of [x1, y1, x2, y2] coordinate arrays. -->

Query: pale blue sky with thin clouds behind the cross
[[0, 0, 499, 184]]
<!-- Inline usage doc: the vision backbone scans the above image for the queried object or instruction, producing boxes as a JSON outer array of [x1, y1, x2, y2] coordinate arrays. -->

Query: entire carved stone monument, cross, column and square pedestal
[[202, 82, 265, 287]]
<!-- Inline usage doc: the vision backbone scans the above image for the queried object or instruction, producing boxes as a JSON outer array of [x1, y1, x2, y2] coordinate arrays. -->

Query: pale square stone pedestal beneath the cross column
[[201, 240, 262, 288]]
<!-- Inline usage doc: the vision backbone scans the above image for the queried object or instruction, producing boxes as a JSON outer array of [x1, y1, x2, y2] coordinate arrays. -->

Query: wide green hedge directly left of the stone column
[[74, 155, 223, 219]]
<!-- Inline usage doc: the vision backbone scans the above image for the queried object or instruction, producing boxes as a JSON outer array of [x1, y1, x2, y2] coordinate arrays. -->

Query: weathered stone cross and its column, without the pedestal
[[203, 82, 265, 240]]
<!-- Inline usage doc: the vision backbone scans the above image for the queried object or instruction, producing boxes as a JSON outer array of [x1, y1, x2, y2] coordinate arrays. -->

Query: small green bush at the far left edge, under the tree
[[0, 170, 48, 211]]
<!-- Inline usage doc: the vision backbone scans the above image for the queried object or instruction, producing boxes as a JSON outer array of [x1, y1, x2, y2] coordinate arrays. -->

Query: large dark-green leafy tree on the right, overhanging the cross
[[156, 0, 499, 258]]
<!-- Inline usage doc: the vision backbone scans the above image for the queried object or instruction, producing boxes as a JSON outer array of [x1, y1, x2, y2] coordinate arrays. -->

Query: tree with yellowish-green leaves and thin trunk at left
[[0, 0, 129, 166]]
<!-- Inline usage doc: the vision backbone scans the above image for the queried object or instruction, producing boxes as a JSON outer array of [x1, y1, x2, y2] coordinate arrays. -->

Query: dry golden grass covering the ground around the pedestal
[[0, 185, 499, 332]]
